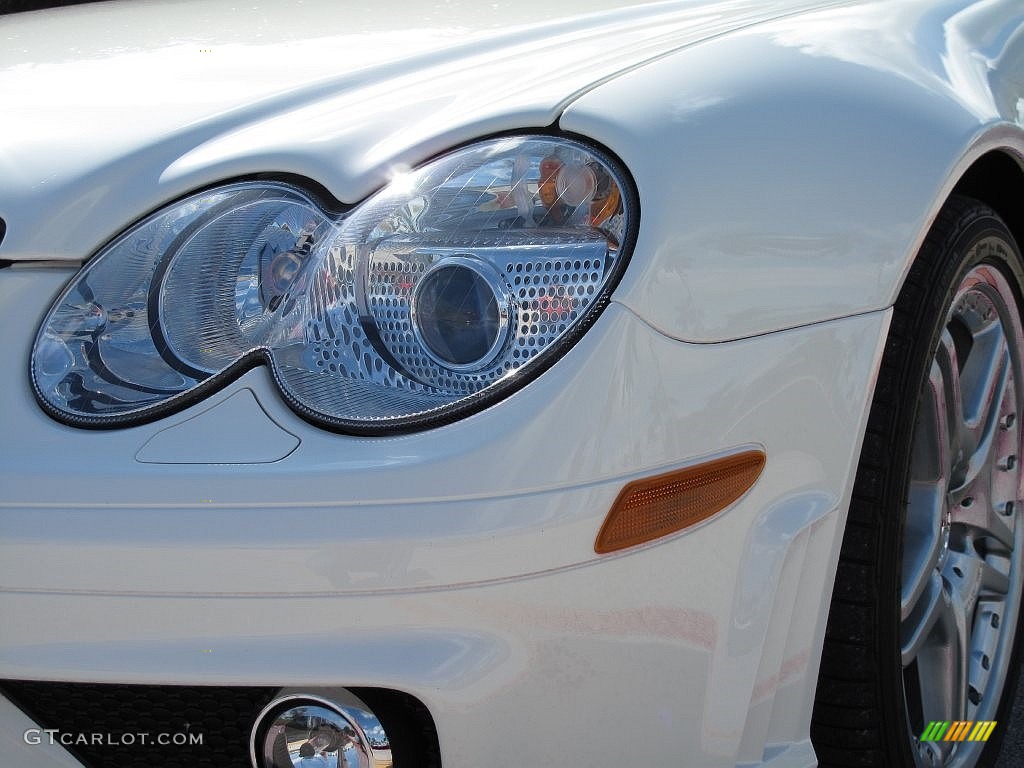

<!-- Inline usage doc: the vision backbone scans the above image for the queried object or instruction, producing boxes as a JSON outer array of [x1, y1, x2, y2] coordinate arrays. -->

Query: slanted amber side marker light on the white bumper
[[594, 451, 765, 555]]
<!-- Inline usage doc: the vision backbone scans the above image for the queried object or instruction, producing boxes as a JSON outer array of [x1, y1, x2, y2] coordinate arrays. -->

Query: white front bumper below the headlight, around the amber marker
[[0, 266, 889, 768]]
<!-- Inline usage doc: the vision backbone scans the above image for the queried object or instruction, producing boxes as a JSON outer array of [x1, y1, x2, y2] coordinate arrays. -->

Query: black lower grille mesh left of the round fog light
[[0, 681, 279, 768]]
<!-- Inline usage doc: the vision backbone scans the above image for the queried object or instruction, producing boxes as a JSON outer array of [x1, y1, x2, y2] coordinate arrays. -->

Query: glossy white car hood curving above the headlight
[[0, 0, 837, 261]]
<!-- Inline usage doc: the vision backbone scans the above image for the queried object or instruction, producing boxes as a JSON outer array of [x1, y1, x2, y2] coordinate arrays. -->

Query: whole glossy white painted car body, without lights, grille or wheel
[[0, 0, 1024, 768]]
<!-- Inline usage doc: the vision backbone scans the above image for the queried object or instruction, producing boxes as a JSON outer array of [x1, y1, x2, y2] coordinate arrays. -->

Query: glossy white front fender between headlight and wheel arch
[[560, 1, 1024, 342]]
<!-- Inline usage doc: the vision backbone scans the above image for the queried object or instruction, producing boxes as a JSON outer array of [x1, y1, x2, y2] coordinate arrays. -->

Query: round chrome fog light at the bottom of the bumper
[[249, 690, 392, 768]]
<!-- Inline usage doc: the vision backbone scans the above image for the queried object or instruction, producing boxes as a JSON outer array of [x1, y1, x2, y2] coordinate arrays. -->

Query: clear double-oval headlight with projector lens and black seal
[[32, 137, 637, 433]]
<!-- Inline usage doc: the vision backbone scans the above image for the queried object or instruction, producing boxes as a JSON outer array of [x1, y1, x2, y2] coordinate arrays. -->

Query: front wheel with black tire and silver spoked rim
[[811, 198, 1024, 768]]
